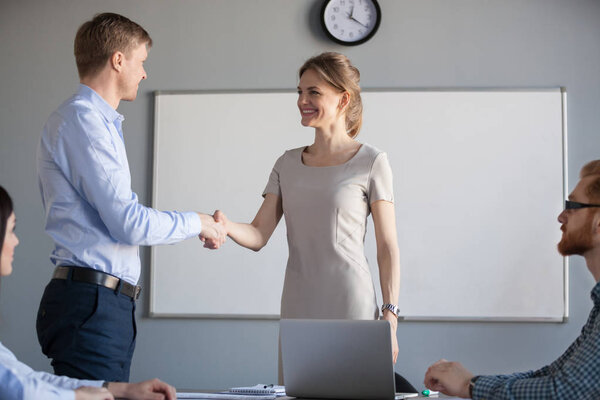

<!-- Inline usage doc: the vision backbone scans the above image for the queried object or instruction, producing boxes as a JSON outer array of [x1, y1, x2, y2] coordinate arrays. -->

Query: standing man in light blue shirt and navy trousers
[[37, 13, 226, 382]]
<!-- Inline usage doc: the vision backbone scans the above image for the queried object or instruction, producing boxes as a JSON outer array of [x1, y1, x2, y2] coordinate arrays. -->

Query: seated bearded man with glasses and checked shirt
[[425, 160, 600, 400]]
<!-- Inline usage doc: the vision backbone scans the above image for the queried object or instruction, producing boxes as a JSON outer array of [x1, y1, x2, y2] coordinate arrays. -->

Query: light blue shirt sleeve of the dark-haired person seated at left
[[0, 343, 103, 400]]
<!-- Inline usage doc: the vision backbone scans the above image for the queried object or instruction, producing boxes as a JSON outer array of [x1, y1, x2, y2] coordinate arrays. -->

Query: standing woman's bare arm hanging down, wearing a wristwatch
[[371, 200, 400, 362]]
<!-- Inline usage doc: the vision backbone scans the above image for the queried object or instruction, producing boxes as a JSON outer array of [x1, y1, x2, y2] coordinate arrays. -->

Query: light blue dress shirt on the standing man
[[37, 84, 202, 284]]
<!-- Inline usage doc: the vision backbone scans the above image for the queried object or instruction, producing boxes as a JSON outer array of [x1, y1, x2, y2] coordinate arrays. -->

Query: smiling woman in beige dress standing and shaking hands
[[210, 53, 400, 384]]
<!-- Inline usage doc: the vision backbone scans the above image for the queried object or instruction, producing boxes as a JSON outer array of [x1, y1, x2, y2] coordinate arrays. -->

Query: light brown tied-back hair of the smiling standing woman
[[298, 52, 362, 138]]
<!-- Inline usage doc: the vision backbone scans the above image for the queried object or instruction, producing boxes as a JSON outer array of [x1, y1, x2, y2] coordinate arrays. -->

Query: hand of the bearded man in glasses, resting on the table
[[424, 359, 474, 399]]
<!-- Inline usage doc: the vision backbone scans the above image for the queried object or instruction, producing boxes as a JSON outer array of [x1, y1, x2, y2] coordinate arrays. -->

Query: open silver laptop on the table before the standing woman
[[279, 319, 416, 400]]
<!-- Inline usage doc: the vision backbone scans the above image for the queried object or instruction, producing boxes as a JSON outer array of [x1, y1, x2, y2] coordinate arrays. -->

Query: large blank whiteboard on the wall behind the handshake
[[150, 88, 568, 321]]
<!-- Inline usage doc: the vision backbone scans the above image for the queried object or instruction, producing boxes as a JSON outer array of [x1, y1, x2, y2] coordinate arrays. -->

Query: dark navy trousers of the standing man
[[36, 279, 136, 382]]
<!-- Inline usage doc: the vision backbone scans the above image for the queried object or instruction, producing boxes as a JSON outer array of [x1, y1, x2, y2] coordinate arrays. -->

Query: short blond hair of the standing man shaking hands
[[73, 13, 152, 78]]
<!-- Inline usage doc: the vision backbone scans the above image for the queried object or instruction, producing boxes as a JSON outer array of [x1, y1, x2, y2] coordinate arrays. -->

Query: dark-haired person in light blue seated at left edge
[[0, 186, 176, 400]]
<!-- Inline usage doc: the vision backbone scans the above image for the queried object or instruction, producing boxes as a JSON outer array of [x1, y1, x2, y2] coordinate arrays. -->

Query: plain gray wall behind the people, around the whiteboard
[[0, 0, 600, 388]]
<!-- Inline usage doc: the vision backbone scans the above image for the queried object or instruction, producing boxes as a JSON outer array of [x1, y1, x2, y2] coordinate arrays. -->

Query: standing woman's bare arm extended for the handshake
[[215, 193, 283, 251]]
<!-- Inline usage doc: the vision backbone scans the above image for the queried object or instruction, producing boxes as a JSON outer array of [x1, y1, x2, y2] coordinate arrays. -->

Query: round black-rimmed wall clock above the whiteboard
[[321, 0, 381, 45]]
